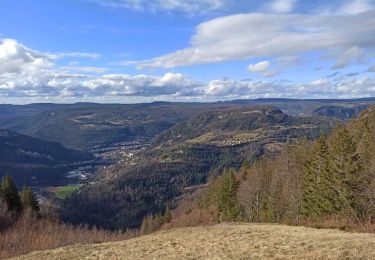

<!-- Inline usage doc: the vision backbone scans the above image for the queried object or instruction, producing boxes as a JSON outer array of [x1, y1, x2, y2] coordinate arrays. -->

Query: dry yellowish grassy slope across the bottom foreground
[[13, 224, 375, 260]]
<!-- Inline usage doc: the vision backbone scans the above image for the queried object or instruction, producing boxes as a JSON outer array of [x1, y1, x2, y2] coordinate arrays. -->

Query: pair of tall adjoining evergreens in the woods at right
[[301, 128, 363, 217]]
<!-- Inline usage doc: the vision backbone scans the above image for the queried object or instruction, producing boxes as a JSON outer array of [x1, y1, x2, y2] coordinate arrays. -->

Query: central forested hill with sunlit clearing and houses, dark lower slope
[[61, 106, 338, 229]]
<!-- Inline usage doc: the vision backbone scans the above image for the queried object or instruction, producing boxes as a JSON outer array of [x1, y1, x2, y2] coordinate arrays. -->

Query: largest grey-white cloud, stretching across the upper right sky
[[138, 10, 375, 68]]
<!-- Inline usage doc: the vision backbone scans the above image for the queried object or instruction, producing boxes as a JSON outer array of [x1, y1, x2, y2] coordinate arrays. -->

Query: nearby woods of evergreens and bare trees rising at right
[[168, 107, 375, 231]]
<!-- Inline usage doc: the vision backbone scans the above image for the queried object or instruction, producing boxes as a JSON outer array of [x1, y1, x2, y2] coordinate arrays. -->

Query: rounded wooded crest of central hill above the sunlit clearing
[[153, 106, 329, 145]]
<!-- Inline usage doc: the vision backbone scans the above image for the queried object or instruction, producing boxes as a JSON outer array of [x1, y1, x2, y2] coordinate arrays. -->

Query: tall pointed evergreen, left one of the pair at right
[[301, 135, 333, 217]]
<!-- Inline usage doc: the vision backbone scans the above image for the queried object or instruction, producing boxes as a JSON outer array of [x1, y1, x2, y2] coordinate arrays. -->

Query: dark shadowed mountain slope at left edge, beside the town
[[0, 129, 93, 186]]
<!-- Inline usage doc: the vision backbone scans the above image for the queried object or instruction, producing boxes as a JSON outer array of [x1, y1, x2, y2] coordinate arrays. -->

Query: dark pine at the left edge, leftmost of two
[[1, 175, 22, 213]]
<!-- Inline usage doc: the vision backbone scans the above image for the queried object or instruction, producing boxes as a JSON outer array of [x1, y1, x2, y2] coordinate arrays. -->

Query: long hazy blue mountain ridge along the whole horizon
[[0, 98, 375, 151]]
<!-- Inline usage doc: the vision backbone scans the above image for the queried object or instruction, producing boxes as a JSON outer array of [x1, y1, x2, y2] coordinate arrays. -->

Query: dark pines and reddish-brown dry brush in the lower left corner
[[0, 176, 139, 259]]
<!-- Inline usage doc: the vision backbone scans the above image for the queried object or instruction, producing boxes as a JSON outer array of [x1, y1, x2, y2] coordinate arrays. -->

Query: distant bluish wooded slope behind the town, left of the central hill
[[0, 103, 214, 151]]
